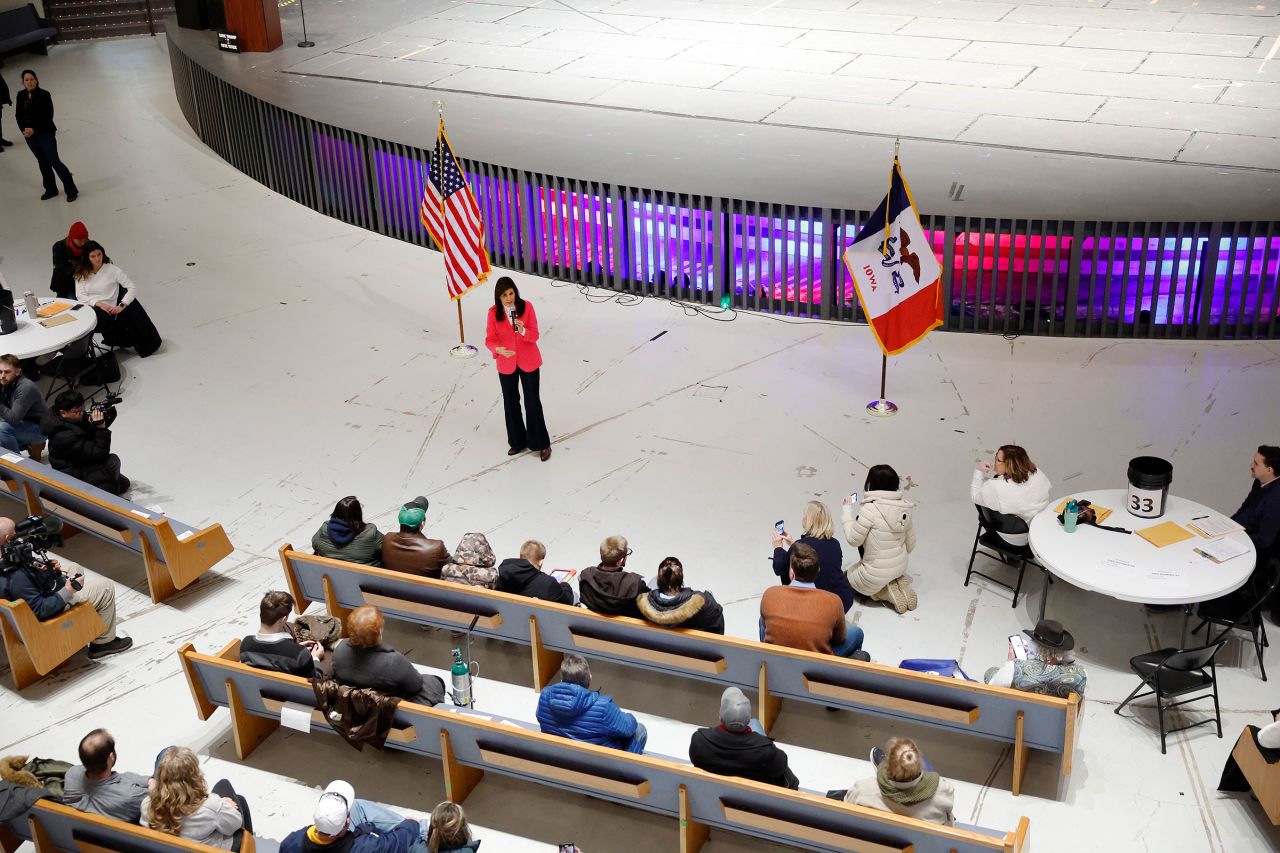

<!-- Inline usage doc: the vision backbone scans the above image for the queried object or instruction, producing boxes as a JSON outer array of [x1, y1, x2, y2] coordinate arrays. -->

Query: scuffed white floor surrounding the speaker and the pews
[[0, 38, 1280, 853]]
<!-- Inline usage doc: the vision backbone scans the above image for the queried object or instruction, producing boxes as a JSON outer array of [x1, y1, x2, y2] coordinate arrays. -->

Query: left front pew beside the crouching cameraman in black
[[0, 453, 232, 603]]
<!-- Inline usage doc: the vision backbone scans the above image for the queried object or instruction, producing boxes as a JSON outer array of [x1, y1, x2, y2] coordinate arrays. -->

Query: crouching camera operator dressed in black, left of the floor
[[41, 391, 129, 494]]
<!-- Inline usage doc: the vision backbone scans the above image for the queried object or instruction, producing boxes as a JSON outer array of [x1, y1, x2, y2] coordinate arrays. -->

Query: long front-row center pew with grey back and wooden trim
[[280, 546, 1080, 795]]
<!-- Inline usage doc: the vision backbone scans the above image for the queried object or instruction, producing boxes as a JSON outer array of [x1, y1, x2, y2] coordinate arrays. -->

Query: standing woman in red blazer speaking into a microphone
[[484, 275, 552, 462]]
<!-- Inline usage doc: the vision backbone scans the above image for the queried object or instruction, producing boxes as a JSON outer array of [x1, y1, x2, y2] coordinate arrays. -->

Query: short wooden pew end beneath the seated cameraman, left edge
[[0, 601, 106, 690]]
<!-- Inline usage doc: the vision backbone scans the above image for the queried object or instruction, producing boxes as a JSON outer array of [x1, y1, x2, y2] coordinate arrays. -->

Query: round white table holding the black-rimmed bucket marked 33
[[1029, 489, 1257, 637]]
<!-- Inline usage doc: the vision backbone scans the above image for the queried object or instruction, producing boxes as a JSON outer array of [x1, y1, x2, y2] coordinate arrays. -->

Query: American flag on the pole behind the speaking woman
[[419, 122, 489, 300]]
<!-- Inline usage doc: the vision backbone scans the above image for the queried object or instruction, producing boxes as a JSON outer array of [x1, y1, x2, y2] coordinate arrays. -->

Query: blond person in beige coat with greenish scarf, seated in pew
[[845, 738, 956, 826]]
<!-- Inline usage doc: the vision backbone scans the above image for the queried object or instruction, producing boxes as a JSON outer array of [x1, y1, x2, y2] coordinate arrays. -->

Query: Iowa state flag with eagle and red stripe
[[845, 158, 942, 355]]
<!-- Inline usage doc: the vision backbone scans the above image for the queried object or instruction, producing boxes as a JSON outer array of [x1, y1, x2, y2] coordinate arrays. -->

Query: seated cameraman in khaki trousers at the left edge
[[0, 515, 133, 661]]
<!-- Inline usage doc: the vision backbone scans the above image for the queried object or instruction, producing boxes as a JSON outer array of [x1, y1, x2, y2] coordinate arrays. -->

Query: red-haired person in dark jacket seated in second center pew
[[333, 605, 444, 704]]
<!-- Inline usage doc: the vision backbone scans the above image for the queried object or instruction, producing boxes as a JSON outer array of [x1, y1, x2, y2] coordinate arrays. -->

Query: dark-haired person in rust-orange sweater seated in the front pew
[[760, 542, 869, 660]]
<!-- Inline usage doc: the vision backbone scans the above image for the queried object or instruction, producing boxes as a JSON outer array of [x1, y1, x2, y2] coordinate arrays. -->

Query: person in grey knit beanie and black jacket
[[689, 688, 800, 790]]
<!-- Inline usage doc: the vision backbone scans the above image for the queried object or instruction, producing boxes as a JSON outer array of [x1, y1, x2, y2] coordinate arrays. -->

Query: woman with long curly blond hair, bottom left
[[141, 747, 253, 850]]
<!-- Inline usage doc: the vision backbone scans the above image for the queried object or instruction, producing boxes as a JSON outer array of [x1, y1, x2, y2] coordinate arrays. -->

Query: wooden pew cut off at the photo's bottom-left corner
[[18, 799, 262, 853]]
